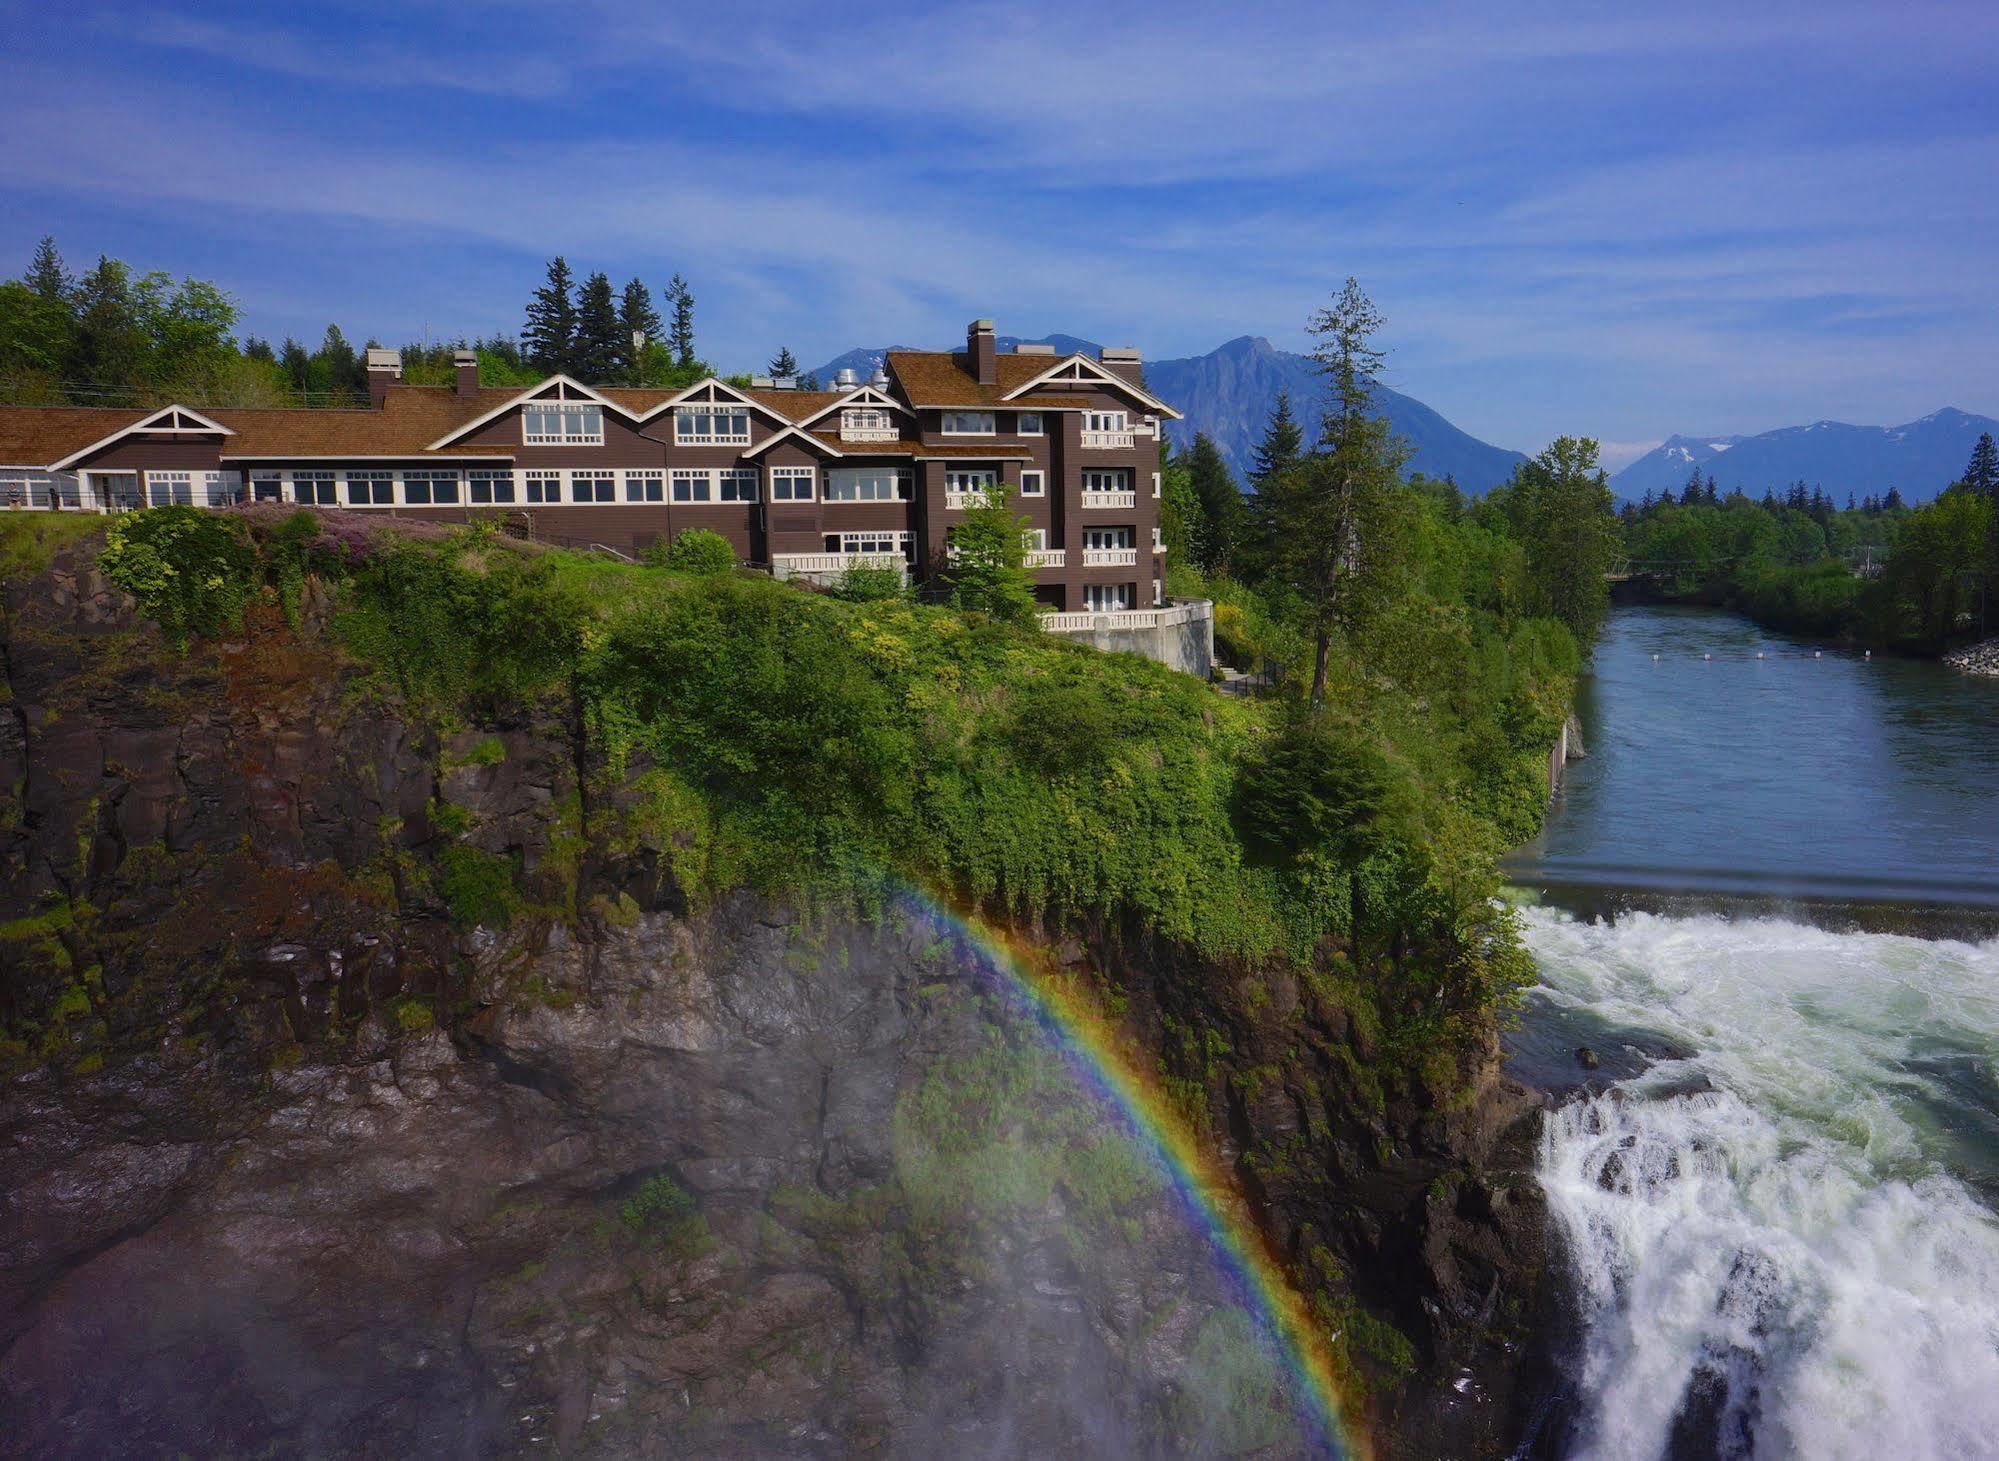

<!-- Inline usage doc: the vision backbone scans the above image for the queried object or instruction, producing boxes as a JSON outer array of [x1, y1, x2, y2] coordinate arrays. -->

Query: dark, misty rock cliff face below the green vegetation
[[0, 552, 1543, 1455]]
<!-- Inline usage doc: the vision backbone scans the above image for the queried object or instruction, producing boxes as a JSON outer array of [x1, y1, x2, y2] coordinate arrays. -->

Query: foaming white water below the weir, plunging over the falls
[[1527, 911, 1999, 1461]]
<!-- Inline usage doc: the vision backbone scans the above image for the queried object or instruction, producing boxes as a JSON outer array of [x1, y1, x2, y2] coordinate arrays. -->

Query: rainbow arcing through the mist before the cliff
[[908, 891, 1367, 1457]]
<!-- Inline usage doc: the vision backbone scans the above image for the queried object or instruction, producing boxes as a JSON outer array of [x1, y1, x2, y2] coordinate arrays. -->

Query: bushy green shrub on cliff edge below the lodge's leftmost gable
[[98, 508, 258, 650]]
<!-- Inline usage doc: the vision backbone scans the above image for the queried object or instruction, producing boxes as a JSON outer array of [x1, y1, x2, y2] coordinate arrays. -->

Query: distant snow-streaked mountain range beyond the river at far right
[[1611, 406, 1999, 502]]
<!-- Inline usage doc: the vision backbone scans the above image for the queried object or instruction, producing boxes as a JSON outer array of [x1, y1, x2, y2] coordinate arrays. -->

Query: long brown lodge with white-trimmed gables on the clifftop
[[0, 320, 1179, 614]]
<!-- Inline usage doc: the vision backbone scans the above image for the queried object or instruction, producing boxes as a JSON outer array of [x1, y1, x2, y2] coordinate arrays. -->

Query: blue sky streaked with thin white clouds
[[0, 0, 1999, 464]]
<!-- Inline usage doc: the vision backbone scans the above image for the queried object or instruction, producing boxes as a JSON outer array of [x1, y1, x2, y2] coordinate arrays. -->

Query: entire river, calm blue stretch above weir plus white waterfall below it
[[1511, 608, 1999, 1459]]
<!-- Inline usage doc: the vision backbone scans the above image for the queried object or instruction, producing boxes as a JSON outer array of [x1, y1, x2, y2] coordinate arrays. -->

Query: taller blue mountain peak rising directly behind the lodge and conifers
[[818, 334, 1525, 492]]
